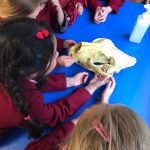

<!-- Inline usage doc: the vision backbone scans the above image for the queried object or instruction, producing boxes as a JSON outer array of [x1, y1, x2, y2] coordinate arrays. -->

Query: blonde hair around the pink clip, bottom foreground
[[67, 104, 150, 150]]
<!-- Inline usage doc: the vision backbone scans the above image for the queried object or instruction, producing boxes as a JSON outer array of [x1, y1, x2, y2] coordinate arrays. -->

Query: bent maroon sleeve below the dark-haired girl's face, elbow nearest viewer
[[19, 80, 91, 127]]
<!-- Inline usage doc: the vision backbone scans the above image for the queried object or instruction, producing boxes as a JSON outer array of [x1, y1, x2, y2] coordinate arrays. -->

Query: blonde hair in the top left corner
[[0, 0, 41, 18]]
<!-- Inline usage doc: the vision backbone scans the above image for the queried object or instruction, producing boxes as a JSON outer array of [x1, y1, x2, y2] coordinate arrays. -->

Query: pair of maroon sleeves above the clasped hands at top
[[87, 0, 125, 13]]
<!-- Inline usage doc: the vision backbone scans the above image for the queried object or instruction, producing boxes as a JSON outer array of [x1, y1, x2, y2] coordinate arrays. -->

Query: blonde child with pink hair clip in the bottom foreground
[[26, 79, 150, 150]]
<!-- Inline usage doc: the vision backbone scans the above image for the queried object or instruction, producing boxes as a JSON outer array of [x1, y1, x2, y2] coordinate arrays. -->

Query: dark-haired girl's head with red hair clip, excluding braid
[[0, 18, 57, 78]]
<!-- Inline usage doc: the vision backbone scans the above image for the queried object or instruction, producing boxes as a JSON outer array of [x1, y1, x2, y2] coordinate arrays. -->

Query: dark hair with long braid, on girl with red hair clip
[[0, 18, 54, 138]]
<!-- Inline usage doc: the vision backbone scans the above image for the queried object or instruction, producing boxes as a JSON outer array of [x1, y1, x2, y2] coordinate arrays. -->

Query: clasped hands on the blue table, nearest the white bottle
[[94, 6, 112, 24]]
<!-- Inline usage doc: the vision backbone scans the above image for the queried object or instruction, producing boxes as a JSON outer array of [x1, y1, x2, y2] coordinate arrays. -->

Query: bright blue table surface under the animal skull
[[0, 2, 150, 150]]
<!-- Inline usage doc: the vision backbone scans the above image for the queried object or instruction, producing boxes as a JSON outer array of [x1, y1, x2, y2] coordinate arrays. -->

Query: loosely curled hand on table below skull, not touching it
[[67, 72, 88, 87]]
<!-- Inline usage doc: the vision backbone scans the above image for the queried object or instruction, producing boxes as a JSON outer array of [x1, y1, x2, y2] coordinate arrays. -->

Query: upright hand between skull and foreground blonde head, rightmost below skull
[[101, 77, 116, 103]]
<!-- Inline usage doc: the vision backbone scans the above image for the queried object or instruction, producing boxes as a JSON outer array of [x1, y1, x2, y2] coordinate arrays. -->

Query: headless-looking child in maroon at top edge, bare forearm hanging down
[[33, 0, 87, 32]]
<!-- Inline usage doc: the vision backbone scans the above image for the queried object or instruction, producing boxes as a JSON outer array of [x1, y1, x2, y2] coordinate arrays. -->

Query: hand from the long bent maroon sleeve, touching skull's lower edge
[[85, 75, 109, 95]]
